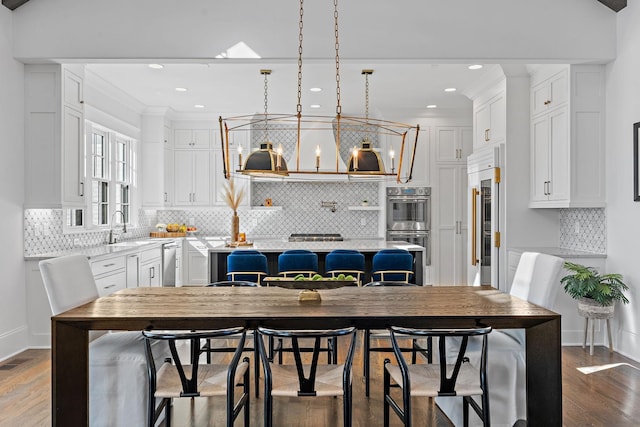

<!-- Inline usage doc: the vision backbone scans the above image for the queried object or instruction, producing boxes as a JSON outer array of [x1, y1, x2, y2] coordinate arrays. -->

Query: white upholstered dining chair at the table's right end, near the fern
[[437, 252, 564, 427]]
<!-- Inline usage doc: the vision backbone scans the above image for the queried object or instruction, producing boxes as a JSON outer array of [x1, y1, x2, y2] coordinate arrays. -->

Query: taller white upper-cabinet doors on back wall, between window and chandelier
[[173, 150, 212, 206]]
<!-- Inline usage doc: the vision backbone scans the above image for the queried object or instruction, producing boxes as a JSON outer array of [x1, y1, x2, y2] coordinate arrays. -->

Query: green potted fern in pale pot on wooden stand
[[560, 261, 629, 319]]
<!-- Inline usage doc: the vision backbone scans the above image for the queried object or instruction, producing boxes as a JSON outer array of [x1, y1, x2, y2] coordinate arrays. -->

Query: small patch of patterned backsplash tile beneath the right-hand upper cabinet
[[560, 208, 607, 254]]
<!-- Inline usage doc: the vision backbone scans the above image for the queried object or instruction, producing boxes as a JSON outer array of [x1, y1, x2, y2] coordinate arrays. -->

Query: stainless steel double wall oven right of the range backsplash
[[387, 187, 431, 265]]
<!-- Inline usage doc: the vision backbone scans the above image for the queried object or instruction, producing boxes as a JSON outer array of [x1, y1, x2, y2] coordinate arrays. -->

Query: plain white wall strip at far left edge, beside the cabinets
[[0, 7, 27, 360]]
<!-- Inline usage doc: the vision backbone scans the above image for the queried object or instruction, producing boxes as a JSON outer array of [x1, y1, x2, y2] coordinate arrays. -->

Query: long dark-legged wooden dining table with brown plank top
[[51, 286, 562, 427]]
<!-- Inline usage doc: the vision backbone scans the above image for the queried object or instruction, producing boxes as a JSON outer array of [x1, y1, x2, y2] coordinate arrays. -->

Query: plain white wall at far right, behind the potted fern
[[606, 1, 640, 360]]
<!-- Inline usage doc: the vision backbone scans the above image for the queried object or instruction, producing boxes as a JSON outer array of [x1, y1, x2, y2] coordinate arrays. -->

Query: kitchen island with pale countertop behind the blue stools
[[208, 239, 426, 285]]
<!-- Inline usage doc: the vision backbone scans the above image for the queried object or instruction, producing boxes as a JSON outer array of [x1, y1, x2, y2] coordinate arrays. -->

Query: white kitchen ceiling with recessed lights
[[86, 60, 499, 120]]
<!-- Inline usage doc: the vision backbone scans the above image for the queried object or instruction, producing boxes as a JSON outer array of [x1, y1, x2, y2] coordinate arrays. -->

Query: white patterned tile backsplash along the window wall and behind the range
[[24, 182, 383, 256]]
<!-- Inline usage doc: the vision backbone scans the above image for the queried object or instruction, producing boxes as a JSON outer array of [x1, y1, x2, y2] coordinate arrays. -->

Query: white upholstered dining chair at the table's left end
[[39, 255, 171, 427]]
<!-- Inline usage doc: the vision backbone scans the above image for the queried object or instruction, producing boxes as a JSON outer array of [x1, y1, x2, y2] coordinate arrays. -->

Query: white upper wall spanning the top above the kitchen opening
[[14, 0, 616, 63]]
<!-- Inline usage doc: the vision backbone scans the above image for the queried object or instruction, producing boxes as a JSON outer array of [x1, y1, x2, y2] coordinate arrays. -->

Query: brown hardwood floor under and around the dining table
[[0, 347, 640, 427]]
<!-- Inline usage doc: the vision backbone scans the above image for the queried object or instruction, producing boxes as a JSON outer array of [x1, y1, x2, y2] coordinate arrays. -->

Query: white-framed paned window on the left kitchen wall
[[87, 123, 136, 227]]
